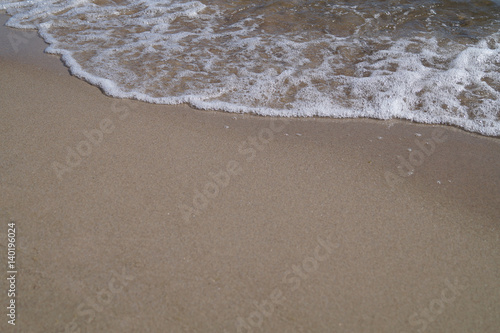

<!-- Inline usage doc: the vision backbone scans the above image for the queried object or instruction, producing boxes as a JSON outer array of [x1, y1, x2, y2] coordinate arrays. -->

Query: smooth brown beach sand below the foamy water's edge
[[0, 16, 500, 333]]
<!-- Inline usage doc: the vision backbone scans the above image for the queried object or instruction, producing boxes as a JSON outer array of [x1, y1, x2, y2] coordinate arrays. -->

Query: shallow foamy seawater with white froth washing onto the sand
[[0, 0, 500, 136]]
